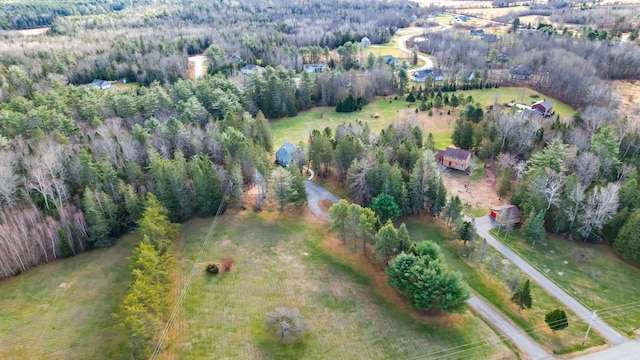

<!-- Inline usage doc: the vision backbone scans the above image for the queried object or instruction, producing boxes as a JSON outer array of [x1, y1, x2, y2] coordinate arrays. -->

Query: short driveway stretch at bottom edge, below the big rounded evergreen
[[467, 295, 554, 360]]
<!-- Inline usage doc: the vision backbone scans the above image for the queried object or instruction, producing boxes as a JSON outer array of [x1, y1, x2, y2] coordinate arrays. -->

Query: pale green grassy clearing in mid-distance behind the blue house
[[271, 96, 453, 148]]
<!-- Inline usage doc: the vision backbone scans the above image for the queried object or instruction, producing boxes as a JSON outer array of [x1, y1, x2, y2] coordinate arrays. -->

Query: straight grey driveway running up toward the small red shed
[[476, 215, 629, 345]]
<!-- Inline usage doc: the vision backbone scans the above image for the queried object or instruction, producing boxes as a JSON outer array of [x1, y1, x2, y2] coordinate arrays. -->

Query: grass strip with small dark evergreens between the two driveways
[[407, 219, 604, 354]]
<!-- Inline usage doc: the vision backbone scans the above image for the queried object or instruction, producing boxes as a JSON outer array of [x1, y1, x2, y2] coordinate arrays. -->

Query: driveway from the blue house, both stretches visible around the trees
[[304, 184, 553, 360]]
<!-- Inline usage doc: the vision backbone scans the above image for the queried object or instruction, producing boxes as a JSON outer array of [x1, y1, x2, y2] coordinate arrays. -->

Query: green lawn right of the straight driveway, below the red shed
[[496, 231, 640, 336]]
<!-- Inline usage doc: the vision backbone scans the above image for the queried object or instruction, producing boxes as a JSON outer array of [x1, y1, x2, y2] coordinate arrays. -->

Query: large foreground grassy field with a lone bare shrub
[[167, 211, 514, 359]]
